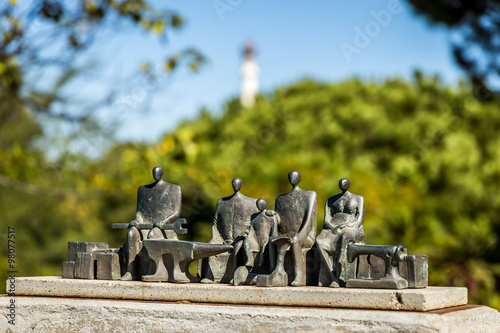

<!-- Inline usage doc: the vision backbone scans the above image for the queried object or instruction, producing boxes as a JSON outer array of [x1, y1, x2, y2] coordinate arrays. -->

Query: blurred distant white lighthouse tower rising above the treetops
[[240, 44, 259, 108]]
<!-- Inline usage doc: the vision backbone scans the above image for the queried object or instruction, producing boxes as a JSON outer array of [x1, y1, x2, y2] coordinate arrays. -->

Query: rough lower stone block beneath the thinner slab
[[0, 294, 500, 333]]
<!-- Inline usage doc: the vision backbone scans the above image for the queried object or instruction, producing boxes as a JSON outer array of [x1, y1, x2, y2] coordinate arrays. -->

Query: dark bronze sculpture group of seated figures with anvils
[[62, 167, 428, 289]]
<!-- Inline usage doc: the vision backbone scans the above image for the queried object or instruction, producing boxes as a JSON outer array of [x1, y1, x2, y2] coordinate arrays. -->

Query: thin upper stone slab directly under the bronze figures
[[16, 277, 467, 311]]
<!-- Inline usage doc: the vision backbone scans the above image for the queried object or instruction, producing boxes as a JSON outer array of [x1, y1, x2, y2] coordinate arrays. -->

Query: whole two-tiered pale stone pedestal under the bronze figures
[[0, 277, 500, 333]]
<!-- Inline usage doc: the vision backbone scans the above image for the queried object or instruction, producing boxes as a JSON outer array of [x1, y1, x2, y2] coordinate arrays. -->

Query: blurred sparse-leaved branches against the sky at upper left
[[0, 0, 204, 141]]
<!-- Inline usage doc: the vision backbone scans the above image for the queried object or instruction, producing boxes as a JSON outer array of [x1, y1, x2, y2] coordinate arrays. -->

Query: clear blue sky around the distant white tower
[[81, 0, 462, 142]]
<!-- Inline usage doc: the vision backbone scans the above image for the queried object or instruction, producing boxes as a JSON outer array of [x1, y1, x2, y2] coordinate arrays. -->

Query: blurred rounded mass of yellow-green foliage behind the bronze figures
[[0, 73, 500, 308]]
